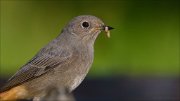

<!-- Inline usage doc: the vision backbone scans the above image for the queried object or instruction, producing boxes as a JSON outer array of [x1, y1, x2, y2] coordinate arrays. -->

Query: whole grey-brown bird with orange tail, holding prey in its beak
[[0, 15, 114, 100]]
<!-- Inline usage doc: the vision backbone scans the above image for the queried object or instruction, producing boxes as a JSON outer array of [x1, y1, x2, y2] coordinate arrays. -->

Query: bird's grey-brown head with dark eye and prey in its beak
[[65, 15, 113, 42]]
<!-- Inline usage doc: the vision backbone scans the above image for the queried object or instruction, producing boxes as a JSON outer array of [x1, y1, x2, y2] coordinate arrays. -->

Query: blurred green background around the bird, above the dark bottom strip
[[0, 0, 180, 77]]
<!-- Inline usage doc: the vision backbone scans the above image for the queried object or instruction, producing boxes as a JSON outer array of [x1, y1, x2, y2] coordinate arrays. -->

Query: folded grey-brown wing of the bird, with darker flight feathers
[[0, 47, 72, 92]]
